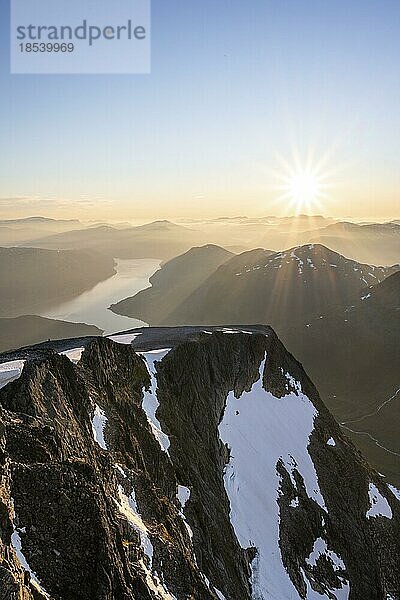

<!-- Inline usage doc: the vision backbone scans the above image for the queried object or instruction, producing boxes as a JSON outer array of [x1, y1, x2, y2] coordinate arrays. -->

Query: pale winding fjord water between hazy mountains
[[41, 258, 160, 334]]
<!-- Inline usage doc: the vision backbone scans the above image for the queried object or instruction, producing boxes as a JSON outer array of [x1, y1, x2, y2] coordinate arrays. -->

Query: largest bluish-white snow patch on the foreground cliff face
[[218, 359, 326, 600]]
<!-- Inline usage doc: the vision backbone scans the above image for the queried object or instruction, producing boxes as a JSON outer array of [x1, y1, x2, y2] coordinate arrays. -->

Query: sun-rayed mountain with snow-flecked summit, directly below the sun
[[113, 244, 400, 331]]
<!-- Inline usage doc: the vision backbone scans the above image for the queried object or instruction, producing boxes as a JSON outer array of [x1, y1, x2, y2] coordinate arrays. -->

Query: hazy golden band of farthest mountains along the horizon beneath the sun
[[0, 214, 400, 265]]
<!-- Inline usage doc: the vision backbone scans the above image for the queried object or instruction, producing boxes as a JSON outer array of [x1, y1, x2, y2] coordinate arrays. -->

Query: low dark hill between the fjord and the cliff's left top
[[0, 315, 103, 352]]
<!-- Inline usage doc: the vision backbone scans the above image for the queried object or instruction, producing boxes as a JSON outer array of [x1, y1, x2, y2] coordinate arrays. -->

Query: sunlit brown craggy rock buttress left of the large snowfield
[[0, 340, 214, 600]]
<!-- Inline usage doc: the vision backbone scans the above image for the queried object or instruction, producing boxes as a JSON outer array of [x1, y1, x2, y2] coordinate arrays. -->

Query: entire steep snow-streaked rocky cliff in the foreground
[[0, 328, 400, 600]]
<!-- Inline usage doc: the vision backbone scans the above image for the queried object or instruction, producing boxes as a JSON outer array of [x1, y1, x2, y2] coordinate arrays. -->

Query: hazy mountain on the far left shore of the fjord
[[0, 248, 115, 317]]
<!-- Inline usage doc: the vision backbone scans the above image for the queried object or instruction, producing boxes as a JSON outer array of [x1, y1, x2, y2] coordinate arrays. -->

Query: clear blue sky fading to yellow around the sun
[[0, 0, 400, 221]]
